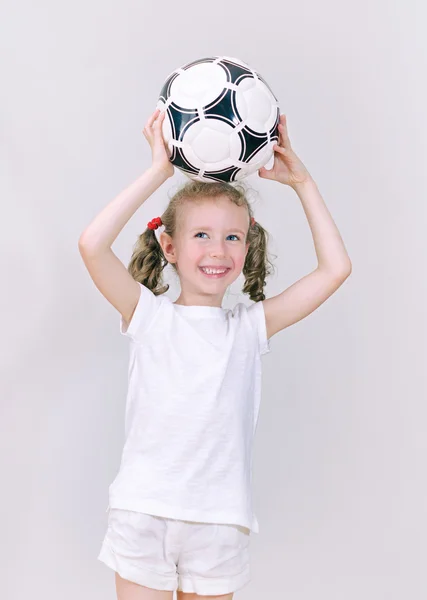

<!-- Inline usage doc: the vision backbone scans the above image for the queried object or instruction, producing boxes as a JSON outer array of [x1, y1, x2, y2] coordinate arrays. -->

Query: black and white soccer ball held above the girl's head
[[157, 56, 280, 182]]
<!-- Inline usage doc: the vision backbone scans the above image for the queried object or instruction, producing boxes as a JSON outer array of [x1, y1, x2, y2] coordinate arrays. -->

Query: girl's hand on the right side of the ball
[[258, 115, 311, 187]]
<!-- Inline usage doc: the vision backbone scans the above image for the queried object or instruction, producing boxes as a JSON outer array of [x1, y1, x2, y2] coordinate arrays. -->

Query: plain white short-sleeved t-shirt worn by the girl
[[109, 284, 270, 533]]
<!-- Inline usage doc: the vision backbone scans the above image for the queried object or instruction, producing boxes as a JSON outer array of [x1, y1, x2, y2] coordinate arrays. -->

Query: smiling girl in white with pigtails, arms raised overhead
[[79, 110, 351, 600]]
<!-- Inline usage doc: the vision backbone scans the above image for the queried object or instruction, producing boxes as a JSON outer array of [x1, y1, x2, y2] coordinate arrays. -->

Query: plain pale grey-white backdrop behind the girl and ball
[[0, 0, 427, 600]]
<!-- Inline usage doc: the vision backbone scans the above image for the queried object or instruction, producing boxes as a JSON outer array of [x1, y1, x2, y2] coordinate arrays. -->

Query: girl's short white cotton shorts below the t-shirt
[[98, 508, 251, 596]]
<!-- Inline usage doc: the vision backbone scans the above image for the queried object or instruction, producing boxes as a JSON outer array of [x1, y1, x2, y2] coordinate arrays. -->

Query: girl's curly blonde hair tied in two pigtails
[[128, 180, 274, 302]]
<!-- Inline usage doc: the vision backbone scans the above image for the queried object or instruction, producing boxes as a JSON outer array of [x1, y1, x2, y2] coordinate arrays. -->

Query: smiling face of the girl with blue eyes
[[163, 196, 249, 306]]
